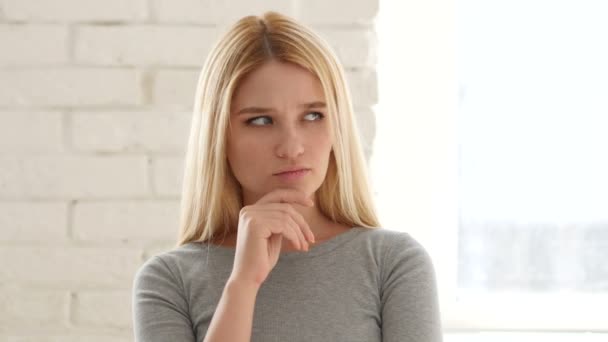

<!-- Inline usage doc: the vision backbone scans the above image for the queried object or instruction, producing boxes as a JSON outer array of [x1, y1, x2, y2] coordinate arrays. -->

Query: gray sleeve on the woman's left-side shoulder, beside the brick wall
[[132, 256, 195, 342]]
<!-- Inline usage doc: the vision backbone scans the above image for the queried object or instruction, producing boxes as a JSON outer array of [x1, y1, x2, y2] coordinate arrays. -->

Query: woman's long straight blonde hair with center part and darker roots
[[177, 12, 379, 246]]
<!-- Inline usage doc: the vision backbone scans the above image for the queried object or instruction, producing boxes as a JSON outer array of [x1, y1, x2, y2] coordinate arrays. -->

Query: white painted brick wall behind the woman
[[0, 0, 378, 342]]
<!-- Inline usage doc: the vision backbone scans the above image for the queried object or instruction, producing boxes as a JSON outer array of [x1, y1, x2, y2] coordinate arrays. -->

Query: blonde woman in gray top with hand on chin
[[133, 12, 441, 342]]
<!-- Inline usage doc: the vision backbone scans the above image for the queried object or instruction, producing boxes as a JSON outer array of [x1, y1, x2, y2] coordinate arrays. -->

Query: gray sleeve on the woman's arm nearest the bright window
[[381, 232, 443, 342]]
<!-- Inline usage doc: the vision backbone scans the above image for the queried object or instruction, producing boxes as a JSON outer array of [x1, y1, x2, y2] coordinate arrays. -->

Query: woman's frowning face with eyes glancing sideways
[[227, 61, 332, 205]]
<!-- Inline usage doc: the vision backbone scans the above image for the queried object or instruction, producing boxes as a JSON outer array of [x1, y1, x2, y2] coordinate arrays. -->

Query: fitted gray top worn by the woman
[[133, 227, 442, 342]]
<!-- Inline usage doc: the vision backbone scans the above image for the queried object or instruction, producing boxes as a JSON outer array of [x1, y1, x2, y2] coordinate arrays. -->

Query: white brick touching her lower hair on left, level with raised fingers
[[72, 200, 179, 242]]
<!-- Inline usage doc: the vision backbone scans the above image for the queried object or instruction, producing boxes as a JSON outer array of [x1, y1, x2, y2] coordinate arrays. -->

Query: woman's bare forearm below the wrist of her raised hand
[[203, 280, 259, 342]]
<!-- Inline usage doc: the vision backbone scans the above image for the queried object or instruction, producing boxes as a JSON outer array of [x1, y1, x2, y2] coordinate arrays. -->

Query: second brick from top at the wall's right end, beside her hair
[[317, 28, 376, 68]]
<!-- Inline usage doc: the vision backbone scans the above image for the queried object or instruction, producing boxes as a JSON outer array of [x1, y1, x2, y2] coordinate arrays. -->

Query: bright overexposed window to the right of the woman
[[372, 0, 608, 331]]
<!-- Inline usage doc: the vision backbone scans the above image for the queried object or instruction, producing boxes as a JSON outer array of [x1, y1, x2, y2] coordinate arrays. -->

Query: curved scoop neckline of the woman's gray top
[[200, 227, 369, 263]]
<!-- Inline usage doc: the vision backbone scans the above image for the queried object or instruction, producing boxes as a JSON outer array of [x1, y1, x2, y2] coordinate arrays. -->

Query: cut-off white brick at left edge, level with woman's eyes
[[0, 112, 64, 154]]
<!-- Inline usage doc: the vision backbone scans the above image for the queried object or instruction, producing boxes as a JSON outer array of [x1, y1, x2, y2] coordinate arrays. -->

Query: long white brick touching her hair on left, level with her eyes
[[71, 112, 192, 154]]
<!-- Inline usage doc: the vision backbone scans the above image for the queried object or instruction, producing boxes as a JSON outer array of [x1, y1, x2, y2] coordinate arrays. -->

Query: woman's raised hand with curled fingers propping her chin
[[230, 189, 314, 288]]
